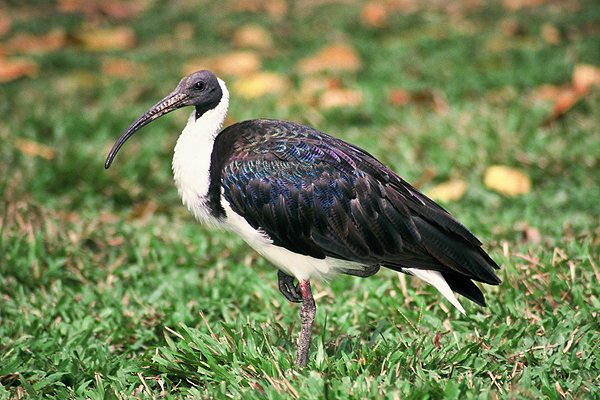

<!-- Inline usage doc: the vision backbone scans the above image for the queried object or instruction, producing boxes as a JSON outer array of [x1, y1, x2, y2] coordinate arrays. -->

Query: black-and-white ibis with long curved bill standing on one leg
[[105, 70, 501, 368]]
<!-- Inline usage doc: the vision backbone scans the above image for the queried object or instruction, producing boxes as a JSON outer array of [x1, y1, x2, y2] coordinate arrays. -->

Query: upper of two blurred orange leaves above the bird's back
[[297, 45, 361, 74]]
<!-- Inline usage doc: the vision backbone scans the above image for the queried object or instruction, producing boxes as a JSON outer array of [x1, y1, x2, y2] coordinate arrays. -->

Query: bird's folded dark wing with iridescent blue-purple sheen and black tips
[[218, 120, 500, 303]]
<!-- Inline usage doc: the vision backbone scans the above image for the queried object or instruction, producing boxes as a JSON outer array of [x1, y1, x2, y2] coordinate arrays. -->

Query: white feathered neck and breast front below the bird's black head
[[173, 79, 229, 222]]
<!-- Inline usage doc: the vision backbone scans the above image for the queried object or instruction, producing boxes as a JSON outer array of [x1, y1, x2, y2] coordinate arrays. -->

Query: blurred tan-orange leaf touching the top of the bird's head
[[184, 50, 262, 76]]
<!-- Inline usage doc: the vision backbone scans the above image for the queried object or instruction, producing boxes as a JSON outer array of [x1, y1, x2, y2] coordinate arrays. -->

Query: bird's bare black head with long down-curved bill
[[104, 70, 223, 169]]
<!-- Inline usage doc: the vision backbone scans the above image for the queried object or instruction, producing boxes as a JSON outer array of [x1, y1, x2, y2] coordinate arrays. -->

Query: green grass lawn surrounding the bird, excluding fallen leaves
[[0, 1, 600, 399]]
